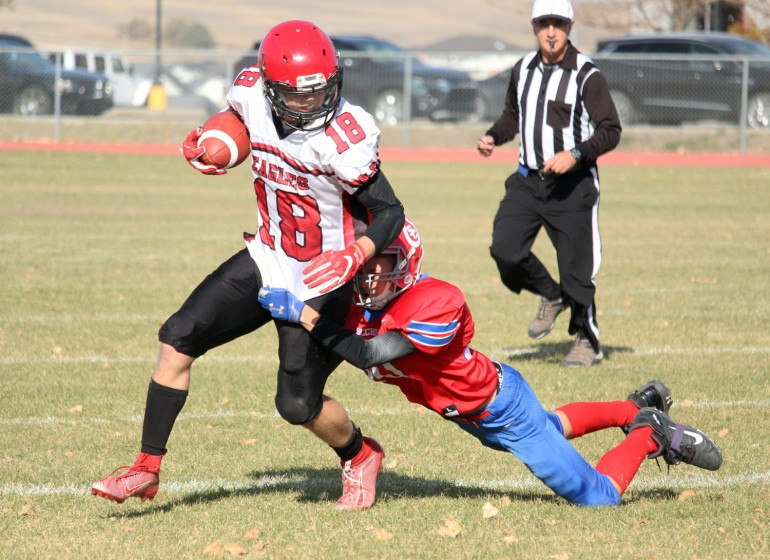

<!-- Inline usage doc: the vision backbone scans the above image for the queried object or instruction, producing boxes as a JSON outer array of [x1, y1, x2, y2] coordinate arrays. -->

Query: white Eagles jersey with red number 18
[[227, 69, 380, 300]]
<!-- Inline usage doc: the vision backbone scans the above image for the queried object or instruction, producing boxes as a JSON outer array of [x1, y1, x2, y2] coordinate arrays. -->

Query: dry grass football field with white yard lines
[[0, 152, 770, 560]]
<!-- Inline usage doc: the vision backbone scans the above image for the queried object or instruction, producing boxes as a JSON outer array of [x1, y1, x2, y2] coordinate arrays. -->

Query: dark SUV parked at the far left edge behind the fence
[[0, 35, 113, 115]]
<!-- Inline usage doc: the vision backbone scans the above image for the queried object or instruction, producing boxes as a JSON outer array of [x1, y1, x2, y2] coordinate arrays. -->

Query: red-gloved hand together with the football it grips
[[182, 109, 251, 175]]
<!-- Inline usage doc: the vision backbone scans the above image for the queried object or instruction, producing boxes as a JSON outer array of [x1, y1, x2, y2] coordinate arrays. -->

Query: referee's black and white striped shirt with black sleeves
[[487, 43, 621, 169]]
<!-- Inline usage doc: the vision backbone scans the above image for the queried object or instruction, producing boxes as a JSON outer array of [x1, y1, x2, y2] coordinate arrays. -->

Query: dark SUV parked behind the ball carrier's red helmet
[[234, 35, 476, 125]]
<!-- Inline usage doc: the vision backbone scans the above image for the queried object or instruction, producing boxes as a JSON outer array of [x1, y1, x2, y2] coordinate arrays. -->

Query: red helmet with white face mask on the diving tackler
[[353, 218, 423, 310]]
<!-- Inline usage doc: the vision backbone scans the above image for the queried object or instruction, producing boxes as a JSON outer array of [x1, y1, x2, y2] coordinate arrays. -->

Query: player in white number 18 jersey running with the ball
[[92, 21, 404, 510]]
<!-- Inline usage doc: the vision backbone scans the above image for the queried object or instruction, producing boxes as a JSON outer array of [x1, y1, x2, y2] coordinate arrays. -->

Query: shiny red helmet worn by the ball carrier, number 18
[[258, 20, 342, 130]]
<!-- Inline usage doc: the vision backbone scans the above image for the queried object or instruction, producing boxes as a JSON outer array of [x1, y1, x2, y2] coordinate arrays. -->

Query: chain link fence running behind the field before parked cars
[[0, 41, 770, 152]]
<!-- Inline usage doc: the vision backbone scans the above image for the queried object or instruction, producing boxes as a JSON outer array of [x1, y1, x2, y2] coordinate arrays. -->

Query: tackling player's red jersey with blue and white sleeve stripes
[[347, 276, 498, 414]]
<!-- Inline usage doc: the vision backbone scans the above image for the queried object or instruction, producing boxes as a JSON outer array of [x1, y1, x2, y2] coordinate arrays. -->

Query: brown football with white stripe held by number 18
[[198, 109, 251, 169]]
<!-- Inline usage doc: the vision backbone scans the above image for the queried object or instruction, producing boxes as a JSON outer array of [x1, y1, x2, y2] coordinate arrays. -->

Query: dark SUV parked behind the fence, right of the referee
[[592, 32, 770, 128]]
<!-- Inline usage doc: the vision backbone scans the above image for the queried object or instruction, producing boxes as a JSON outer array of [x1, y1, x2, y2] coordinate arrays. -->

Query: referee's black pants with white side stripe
[[490, 166, 601, 350]]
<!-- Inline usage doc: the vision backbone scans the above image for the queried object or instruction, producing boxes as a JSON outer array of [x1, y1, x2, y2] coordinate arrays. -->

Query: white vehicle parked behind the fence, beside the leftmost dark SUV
[[43, 49, 153, 107]]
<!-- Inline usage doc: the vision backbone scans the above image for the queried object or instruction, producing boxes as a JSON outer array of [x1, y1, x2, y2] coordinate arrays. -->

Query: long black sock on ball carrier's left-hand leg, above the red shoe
[[142, 379, 187, 455]]
